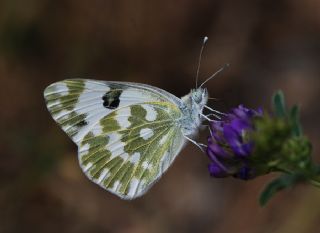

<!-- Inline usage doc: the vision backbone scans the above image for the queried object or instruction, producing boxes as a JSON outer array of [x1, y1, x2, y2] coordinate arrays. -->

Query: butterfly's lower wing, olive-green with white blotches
[[79, 102, 185, 199]]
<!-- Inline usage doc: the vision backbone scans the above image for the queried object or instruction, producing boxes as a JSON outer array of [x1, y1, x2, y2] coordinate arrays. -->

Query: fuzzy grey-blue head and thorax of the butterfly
[[179, 88, 208, 136]]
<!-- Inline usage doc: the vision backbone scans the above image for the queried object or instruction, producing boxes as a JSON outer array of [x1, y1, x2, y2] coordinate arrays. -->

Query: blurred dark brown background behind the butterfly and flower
[[0, 0, 320, 233]]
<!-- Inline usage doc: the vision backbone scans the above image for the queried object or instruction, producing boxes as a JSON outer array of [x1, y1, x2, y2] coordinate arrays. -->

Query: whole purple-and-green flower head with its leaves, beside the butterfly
[[207, 91, 320, 205]]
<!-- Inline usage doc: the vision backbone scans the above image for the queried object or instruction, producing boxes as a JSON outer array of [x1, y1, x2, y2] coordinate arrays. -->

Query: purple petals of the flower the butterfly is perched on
[[207, 105, 262, 180]]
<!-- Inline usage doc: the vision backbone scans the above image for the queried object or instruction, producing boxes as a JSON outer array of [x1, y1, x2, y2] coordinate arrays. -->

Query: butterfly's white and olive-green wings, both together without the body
[[44, 79, 185, 199]]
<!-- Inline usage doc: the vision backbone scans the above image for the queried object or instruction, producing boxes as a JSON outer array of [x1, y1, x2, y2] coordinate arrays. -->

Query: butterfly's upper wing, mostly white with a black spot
[[44, 79, 178, 145]]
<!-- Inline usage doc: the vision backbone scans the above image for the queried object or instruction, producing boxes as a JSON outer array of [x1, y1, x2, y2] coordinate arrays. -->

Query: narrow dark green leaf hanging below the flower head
[[259, 174, 302, 206]]
